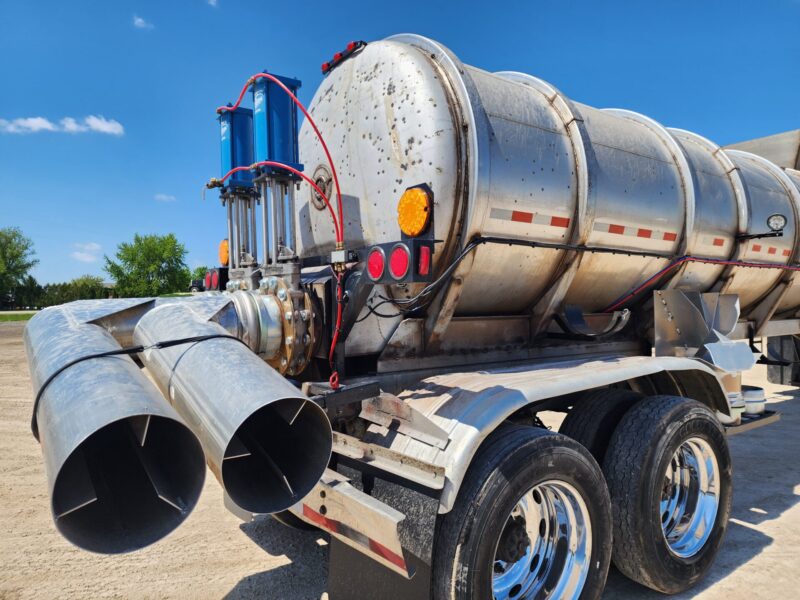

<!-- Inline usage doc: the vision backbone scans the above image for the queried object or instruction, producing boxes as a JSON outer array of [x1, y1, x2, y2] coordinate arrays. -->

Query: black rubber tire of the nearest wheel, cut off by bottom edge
[[432, 425, 611, 600]]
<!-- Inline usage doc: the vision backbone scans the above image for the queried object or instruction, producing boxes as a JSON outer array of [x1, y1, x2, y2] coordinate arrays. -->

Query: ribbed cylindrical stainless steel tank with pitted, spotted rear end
[[296, 35, 800, 342]]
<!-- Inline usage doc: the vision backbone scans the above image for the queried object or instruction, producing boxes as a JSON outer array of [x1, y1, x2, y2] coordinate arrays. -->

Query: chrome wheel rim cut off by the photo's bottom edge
[[492, 480, 592, 600]]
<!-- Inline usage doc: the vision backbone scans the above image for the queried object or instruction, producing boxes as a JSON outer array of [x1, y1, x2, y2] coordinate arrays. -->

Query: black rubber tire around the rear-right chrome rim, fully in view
[[603, 396, 732, 594]]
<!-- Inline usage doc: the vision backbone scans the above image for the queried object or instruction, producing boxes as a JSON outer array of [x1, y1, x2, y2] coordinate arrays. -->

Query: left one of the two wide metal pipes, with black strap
[[25, 305, 205, 554]]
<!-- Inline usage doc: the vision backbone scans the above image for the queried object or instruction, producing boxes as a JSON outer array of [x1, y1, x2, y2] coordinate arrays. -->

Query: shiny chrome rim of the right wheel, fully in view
[[659, 437, 720, 558]]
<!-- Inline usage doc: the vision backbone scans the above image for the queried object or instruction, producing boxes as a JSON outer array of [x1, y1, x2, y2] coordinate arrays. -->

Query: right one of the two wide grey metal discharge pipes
[[134, 303, 332, 513]]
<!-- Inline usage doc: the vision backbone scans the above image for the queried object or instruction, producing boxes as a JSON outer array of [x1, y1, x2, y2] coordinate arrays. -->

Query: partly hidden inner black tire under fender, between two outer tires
[[558, 388, 644, 465]]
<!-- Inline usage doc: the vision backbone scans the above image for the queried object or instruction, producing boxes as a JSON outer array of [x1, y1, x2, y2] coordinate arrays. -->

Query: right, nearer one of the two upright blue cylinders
[[253, 75, 303, 175]]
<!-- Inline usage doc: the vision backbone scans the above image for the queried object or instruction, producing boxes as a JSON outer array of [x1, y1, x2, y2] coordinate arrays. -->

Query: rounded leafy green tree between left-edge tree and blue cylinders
[[104, 233, 189, 298]]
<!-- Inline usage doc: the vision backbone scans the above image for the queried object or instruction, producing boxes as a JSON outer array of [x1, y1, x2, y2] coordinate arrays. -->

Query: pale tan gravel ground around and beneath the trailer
[[0, 323, 800, 600]]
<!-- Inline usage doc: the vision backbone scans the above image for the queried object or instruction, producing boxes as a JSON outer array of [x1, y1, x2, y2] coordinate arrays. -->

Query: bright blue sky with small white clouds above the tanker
[[0, 0, 800, 282]]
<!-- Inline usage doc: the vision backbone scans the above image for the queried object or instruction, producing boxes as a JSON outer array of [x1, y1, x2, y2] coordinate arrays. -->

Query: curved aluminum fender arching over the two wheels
[[382, 356, 727, 513]]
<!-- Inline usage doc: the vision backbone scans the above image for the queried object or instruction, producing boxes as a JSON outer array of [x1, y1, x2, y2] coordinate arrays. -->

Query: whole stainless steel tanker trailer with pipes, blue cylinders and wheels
[[26, 35, 800, 600]]
